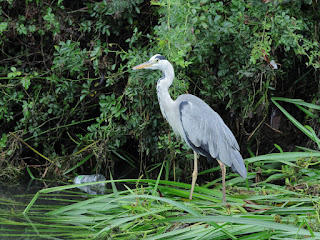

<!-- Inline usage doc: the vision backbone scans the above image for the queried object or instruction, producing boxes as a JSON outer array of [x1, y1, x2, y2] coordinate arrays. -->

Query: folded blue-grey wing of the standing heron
[[177, 95, 247, 178]]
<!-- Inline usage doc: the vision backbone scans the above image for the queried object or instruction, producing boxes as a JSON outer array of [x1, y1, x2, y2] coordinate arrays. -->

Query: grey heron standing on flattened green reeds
[[133, 54, 247, 202]]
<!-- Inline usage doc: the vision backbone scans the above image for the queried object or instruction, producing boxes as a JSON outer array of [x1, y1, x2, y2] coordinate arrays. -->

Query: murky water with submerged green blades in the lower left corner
[[0, 181, 105, 240]]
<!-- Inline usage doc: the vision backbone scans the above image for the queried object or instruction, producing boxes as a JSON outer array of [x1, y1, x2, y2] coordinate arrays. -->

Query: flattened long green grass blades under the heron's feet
[[0, 158, 320, 239]]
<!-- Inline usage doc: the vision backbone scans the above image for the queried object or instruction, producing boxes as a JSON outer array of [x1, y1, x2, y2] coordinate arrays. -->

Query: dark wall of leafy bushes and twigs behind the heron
[[0, 0, 320, 181]]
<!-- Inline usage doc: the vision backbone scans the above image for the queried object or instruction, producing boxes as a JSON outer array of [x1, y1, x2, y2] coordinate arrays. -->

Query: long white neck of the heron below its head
[[157, 62, 174, 120]]
